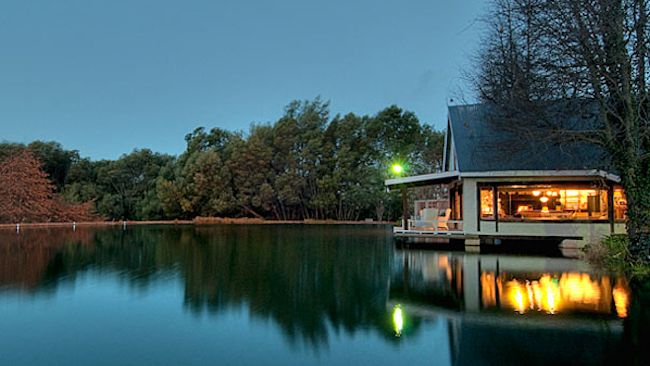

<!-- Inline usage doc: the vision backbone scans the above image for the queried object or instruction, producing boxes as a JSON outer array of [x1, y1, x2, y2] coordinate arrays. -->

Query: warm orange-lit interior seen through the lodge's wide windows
[[480, 184, 627, 221]]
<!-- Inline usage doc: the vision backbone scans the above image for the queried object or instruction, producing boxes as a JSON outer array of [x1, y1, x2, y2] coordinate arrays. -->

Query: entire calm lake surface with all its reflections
[[0, 225, 650, 365]]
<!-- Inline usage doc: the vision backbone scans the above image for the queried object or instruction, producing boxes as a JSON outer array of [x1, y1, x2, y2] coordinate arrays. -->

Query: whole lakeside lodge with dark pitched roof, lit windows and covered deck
[[385, 104, 627, 249]]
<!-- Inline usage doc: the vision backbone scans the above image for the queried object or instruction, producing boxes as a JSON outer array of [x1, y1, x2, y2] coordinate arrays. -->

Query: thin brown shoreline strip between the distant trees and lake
[[0, 217, 395, 230]]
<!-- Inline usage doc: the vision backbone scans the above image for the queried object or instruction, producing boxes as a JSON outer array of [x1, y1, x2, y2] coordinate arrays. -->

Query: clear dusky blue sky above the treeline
[[0, 0, 485, 159]]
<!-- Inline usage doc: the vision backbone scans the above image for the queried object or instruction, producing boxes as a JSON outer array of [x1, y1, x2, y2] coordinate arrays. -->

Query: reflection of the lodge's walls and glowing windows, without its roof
[[391, 251, 630, 318]]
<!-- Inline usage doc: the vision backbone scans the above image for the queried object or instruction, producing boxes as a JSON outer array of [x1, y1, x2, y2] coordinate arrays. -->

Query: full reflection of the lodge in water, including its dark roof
[[388, 251, 630, 364]]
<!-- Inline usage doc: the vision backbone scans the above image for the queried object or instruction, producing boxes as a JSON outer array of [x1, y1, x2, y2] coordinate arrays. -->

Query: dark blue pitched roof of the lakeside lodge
[[442, 103, 612, 172]]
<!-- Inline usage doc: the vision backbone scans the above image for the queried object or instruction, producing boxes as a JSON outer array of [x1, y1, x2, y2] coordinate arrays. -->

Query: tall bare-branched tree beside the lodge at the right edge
[[474, 0, 650, 262]]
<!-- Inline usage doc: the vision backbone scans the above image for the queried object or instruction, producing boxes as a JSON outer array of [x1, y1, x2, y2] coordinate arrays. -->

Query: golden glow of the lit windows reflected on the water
[[481, 272, 630, 318]]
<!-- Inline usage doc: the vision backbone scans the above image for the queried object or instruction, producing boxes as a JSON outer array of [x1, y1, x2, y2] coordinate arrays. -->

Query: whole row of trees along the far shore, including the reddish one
[[0, 99, 444, 222]]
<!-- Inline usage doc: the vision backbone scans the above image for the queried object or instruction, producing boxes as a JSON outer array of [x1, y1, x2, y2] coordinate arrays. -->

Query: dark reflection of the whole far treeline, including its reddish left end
[[0, 225, 392, 346]]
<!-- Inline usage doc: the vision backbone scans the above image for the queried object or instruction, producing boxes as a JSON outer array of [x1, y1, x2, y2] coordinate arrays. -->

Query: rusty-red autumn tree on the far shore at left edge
[[0, 150, 97, 223]]
